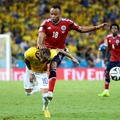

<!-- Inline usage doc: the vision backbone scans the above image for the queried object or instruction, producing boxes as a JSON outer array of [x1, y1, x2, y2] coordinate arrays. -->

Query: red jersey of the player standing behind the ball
[[107, 34, 120, 62]]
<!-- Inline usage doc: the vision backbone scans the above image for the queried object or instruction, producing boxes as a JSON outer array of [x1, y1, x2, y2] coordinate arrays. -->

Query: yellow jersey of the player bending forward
[[24, 47, 47, 72]]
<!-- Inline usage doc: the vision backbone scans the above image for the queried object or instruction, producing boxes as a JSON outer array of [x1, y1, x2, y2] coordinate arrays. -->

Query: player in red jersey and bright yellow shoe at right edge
[[99, 24, 120, 97]]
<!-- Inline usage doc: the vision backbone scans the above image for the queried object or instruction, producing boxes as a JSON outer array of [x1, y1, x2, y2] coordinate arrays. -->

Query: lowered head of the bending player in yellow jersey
[[39, 48, 51, 63]]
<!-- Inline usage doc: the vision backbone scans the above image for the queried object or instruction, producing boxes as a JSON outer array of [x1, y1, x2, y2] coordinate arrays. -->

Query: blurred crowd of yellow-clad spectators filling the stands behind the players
[[0, 0, 120, 67]]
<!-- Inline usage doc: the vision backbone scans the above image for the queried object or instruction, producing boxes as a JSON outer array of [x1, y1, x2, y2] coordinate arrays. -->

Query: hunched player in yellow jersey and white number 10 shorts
[[24, 47, 79, 117]]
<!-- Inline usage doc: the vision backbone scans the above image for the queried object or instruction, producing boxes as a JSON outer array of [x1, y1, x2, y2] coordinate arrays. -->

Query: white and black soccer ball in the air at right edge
[[109, 67, 120, 81]]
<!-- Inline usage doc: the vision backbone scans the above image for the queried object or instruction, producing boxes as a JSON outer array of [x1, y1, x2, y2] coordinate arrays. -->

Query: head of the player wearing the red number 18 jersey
[[50, 5, 61, 23]]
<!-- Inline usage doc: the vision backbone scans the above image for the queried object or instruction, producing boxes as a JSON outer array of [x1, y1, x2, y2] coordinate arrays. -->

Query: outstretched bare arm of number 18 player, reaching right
[[78, 23, 108, 33]]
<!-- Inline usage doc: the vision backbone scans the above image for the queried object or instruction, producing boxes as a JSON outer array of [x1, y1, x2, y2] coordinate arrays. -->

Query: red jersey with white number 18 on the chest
[[39, 18, 80, 49]]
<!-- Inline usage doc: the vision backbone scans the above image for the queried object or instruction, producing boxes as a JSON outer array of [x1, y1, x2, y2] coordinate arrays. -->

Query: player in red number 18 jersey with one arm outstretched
[[37, 5, 107, 99]]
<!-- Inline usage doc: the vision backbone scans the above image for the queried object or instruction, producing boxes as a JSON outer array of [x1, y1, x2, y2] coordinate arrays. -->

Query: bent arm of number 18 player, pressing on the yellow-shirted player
[[37, 32, 46, 49]]
